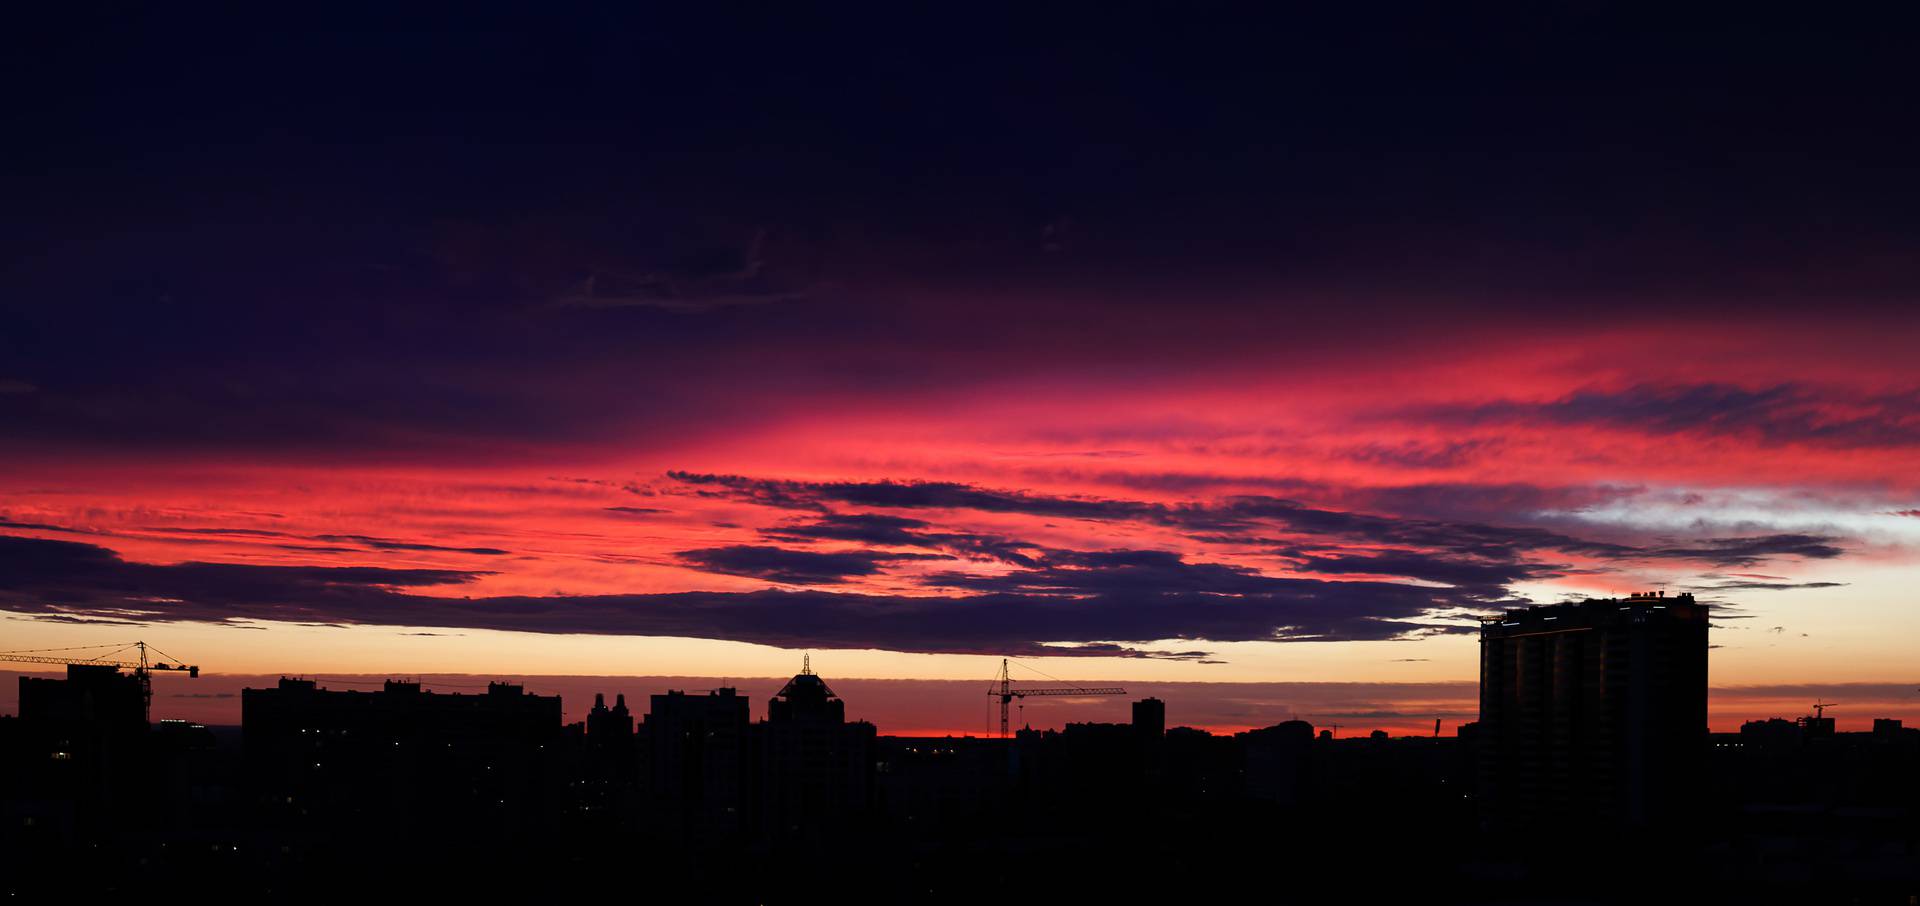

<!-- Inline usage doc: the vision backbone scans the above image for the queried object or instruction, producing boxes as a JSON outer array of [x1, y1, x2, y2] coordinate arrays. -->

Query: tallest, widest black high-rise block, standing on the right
[[1478, 593, 1707, 829]]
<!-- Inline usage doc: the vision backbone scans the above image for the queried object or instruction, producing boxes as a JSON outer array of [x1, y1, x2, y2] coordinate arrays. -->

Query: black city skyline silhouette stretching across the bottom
[[11, 591, 1920, 902]]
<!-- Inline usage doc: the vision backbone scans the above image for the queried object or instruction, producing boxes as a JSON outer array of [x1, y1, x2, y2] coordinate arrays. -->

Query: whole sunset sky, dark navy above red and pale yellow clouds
[[0, 6, 1920, 733]]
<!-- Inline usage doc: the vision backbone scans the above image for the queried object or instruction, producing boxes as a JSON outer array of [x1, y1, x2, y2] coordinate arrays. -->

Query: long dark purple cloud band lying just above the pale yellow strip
[[0, 536, 1453, 658]]
